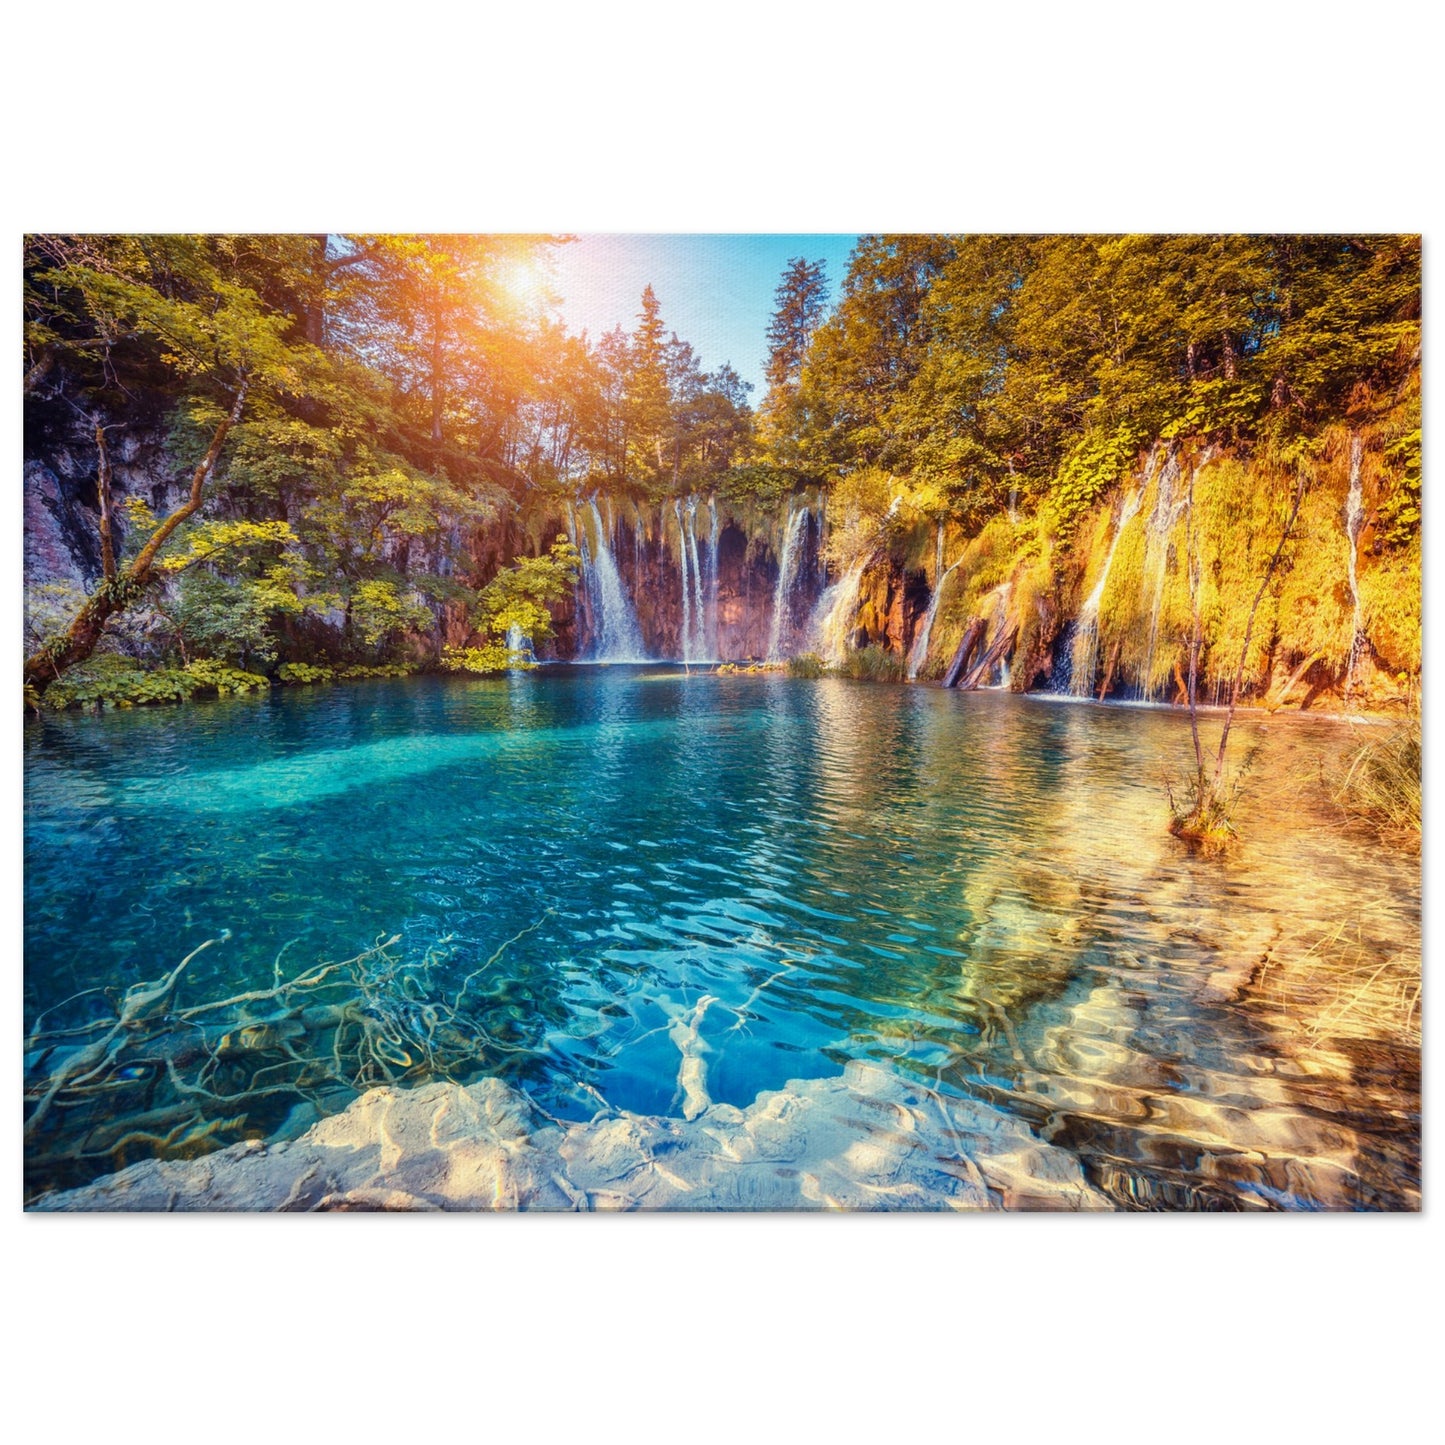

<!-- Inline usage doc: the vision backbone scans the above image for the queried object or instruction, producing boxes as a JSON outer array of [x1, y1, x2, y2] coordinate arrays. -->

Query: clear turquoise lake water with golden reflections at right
[[25, 666, 1420, 1208]]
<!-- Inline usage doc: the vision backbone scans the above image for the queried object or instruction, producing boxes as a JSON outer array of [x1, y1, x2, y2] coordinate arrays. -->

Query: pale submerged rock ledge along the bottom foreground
[[33, 1062, 1111, 1211]]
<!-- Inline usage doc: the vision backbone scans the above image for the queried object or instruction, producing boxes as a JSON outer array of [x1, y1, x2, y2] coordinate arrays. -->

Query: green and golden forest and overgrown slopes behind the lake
[[25, 234, 1420, 734]]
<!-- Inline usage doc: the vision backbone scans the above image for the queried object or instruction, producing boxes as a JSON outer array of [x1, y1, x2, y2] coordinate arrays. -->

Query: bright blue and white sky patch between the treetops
[[553, 236, 857, 406]]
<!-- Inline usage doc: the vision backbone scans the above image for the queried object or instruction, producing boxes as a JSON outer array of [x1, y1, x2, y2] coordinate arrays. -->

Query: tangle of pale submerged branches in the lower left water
[[25, 919, 542, 1192]]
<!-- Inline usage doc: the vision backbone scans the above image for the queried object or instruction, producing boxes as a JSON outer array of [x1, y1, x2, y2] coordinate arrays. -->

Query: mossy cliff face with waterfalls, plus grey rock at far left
[[25, 416, 1420, 708]]
